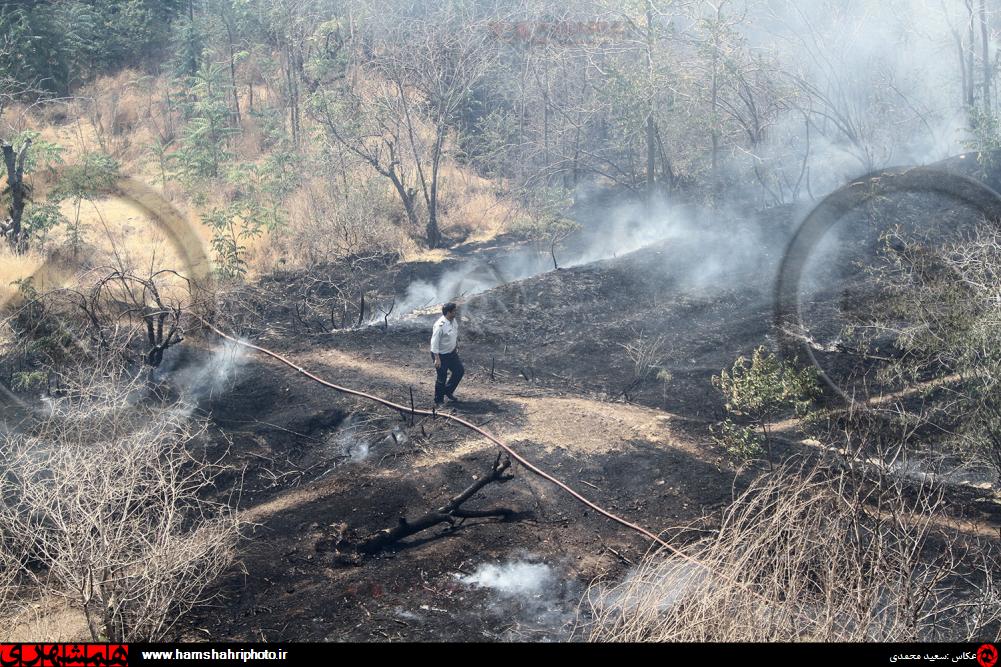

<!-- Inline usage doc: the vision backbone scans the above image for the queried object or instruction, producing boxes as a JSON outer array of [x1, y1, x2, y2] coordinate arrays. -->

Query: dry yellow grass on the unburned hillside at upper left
[[7, 70, 518, 284]]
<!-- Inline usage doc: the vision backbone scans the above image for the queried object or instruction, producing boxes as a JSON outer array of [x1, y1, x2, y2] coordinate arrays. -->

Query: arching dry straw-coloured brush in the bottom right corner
[[579, 468, 1001, 642]]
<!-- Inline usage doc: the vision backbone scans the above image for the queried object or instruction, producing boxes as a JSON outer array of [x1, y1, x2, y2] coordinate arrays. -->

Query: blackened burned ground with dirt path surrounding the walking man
[[1, 169, 1001, 641]]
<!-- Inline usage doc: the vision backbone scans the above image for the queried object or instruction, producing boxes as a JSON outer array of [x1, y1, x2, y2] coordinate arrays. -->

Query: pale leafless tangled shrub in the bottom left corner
[[0, 374, 238, 641]]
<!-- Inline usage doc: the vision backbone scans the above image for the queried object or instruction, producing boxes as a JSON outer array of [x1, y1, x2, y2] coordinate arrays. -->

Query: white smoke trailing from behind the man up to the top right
[[373, 0, 984, 321]]
